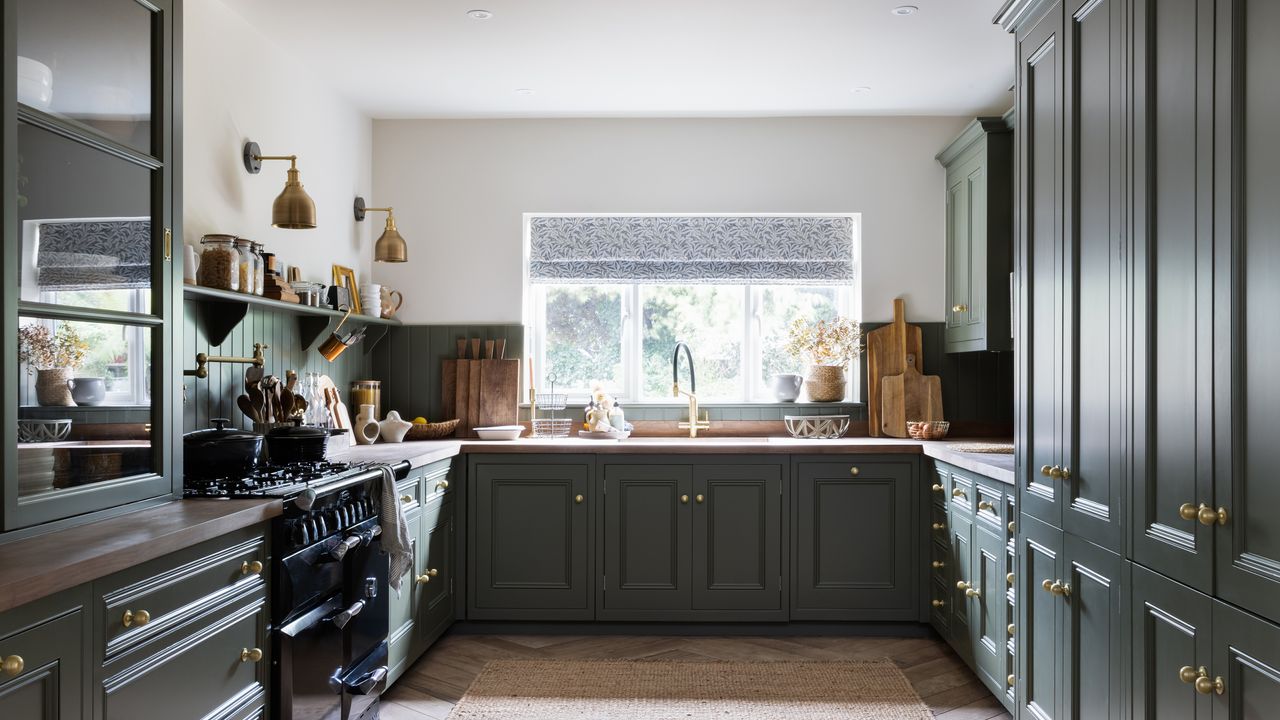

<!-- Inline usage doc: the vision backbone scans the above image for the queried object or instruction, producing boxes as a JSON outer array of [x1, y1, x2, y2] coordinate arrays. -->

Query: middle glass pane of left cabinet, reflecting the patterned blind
[[18, 123, 152, 313]]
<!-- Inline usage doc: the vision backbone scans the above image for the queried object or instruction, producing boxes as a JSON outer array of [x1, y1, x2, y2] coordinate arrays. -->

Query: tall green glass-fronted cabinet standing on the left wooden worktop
[[0, 0, 182, 532]]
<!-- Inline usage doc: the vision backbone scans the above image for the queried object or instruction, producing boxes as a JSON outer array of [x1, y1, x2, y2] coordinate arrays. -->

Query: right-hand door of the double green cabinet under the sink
[[692, 462, 785, 607]]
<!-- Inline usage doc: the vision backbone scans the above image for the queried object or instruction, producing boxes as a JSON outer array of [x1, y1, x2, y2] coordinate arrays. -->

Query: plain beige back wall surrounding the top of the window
[[370, 118, 969, 323]]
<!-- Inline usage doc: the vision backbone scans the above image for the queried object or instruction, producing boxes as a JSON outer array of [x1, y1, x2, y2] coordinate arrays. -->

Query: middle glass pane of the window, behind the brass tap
[[640, 286, 745, 401]]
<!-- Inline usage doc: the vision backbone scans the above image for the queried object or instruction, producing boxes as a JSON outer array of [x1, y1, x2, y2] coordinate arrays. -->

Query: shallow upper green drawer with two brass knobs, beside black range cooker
[[93, 520, 270, 659]]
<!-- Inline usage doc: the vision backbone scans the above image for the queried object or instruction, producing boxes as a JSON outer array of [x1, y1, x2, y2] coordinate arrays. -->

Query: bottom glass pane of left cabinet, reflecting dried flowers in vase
[[14, 318, 155, 496]]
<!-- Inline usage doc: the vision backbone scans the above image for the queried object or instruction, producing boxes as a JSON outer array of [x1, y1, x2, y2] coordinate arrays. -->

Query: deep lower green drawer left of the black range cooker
[[99, 593, 270, 720]]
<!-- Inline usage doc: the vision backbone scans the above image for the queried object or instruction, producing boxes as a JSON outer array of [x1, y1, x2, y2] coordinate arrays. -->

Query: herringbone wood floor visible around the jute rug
[[381, 634, 1009, 720]]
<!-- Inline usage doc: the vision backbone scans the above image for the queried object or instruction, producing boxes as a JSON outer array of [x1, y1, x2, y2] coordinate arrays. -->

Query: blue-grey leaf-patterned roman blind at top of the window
[[529, 215, 855, 284]]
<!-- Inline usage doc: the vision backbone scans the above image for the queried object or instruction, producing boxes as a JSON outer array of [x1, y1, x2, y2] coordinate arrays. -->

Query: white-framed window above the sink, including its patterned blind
[[526, 215, 858, 402]]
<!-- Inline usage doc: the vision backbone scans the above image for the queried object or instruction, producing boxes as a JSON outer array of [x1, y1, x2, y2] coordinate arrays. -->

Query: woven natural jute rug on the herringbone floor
[[449, 660, 932, 720]]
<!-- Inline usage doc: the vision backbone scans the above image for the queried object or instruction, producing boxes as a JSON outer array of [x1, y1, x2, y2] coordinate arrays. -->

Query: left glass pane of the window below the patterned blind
[[538, 286, 622, 393]]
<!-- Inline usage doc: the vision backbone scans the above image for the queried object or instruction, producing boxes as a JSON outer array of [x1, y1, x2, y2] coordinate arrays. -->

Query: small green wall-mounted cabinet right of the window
[[937, 118, 1014, 352]]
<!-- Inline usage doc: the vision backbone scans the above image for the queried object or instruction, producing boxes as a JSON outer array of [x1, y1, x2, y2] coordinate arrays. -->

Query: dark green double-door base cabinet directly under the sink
[[596, 457, 786, 621]]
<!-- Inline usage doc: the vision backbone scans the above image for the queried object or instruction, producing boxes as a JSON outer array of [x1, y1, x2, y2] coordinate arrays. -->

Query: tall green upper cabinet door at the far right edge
[[1213, 0, 1280, 623]]
